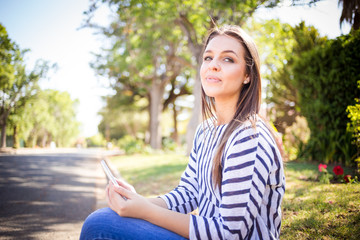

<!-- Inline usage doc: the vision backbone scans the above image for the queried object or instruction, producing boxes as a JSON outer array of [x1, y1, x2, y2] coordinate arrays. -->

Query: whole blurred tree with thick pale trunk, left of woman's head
[[87, 0, 195, 148]]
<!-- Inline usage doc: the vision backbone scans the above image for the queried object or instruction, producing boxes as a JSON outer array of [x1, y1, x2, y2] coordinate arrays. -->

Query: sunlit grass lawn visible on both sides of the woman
[[111, 153, 360, 240]]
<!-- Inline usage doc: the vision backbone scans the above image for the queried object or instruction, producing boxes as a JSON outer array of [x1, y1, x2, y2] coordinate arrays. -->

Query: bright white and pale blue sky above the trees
[[0, 0, 350, 137]]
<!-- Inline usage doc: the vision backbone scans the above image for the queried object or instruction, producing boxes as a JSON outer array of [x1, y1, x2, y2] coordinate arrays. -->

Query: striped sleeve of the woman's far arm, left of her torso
[[160, 124, 201, 213]]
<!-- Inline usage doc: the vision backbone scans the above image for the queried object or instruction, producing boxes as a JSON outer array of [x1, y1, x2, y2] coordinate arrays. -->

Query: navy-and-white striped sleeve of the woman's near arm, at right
[[190, 124, 282, 239]]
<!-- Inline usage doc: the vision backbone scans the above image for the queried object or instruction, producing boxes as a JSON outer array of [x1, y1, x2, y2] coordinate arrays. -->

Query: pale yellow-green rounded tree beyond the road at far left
[[16, 89, 80, 147]]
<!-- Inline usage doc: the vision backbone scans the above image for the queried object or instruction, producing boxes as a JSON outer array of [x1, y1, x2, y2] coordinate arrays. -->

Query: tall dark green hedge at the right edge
[[294, 31, 360, 165]]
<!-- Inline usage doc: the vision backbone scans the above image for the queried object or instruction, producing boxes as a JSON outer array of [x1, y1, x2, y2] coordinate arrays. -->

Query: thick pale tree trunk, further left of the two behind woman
[[149, 80, 164, 149]]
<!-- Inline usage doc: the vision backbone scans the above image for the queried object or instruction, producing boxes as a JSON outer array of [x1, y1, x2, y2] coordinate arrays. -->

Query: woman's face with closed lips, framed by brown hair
[[200, 35, 249, 104]]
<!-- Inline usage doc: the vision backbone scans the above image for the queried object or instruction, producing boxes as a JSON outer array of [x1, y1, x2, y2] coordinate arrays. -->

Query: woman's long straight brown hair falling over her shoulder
[[201, 26, 261, 187]]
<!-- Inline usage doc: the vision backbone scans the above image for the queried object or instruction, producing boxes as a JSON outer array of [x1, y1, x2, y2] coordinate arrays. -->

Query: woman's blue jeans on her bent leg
[[80, 208, 186, 240]]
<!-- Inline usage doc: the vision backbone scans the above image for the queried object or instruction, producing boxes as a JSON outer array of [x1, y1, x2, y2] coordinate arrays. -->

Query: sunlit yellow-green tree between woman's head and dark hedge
[[251, 20, 327, 134]]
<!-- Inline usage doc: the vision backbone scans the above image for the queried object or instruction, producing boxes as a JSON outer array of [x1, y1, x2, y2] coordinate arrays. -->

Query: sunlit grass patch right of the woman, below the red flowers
[[280, 161, 360, 240]]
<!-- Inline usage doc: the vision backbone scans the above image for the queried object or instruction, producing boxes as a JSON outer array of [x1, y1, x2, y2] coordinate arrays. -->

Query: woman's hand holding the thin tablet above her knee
[[106, 182, 153, 219]]
